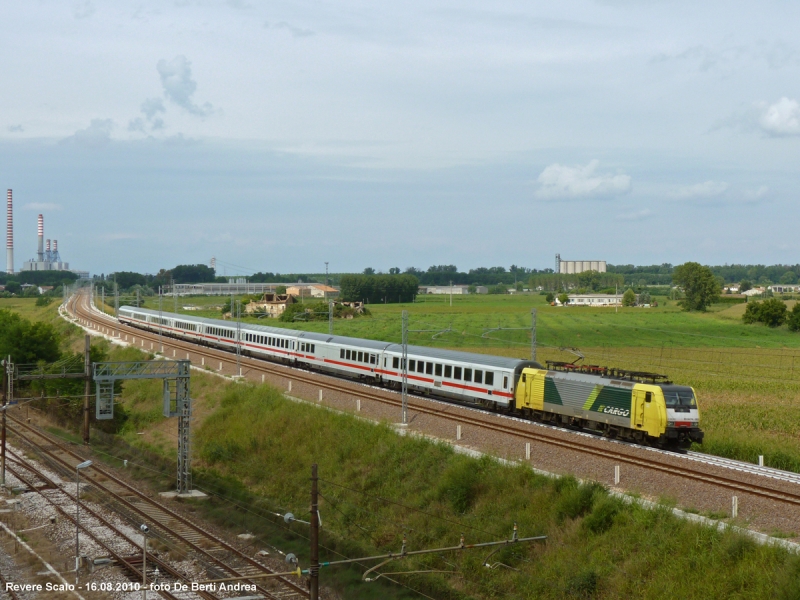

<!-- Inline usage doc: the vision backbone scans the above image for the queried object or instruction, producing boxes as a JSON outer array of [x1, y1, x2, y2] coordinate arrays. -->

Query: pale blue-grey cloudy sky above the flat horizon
[[0, 0, 800, 275]]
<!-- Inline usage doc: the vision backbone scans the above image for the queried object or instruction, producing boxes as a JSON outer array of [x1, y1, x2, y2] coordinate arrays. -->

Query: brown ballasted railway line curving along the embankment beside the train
[[61, 295, 800, 540]]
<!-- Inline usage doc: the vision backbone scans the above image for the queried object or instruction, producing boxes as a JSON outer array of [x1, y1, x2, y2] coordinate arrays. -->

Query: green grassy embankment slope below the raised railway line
[[117, 380, 800, 599]]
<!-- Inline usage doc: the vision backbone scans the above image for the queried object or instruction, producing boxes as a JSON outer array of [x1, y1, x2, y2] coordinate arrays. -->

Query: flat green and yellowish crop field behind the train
[[98, 295, 800, 471]]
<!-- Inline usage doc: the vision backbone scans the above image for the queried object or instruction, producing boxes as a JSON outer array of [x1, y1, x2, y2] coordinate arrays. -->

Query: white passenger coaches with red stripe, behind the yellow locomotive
[[119, 306, 542, 407]]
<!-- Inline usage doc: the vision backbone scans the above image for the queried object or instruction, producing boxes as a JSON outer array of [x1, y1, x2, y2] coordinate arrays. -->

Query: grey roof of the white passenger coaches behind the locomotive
[[120, 306, 544, 370]]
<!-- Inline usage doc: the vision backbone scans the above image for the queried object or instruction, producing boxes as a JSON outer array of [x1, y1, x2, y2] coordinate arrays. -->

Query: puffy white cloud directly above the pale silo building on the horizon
[[536, 160, 631, 199]]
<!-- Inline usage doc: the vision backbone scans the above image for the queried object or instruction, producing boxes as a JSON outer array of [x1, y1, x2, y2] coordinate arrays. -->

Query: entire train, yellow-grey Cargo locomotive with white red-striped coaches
[[119, 306, 703, 447]]
